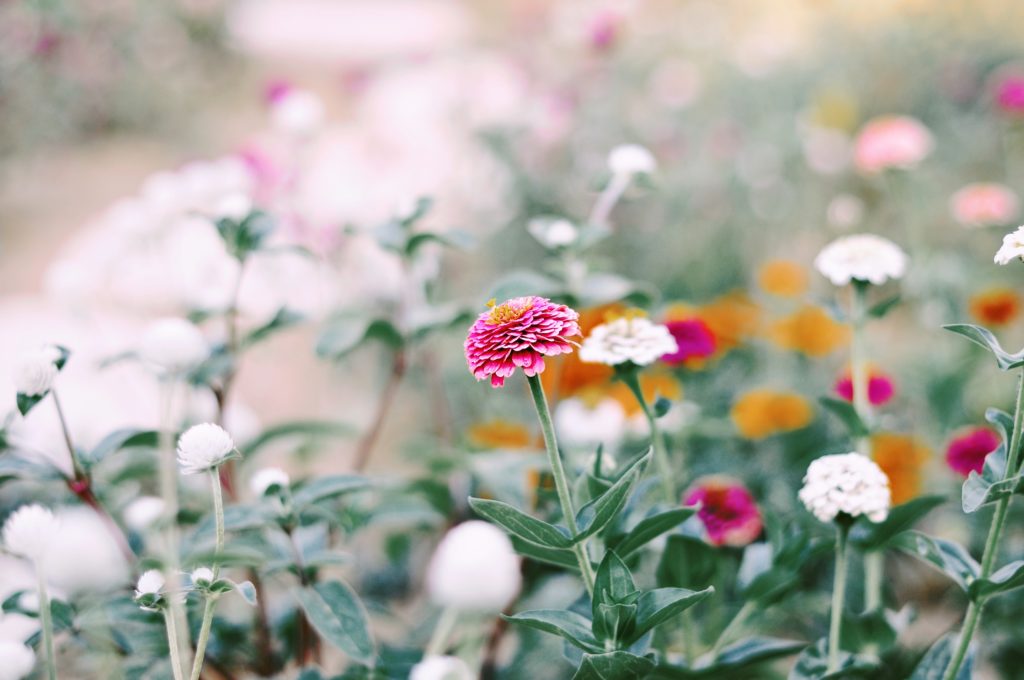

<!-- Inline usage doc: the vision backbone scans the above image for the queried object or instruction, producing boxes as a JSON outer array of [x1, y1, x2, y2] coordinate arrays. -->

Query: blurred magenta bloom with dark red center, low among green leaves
[[683, 475, 763, 546]]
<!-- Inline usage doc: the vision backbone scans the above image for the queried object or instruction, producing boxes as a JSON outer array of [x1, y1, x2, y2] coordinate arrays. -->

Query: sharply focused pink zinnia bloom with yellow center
[[465, 296, 580, 387]]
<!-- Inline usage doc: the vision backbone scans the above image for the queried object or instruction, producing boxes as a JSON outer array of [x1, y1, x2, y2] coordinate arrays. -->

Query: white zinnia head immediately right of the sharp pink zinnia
[[580, 316, 679, 366]]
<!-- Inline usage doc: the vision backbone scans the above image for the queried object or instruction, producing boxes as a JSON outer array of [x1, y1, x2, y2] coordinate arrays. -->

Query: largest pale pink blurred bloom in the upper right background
[[853, 116, 933, 174]]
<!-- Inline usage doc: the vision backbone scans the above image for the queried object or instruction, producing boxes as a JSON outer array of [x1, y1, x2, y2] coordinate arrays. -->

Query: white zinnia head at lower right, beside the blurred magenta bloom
[[800, 453, 892, 522]]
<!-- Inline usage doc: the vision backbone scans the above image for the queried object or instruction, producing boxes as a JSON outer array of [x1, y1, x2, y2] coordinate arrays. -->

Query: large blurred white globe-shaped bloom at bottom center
[[427, 520, 521, 612]]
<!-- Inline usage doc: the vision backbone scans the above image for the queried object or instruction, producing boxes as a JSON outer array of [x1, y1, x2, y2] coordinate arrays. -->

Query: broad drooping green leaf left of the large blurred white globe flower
[[294, 581, 376, 665]]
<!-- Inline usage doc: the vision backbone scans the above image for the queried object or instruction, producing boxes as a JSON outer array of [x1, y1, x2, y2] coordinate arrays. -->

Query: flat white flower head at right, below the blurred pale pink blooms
[[814, 233, 907, 286]]
